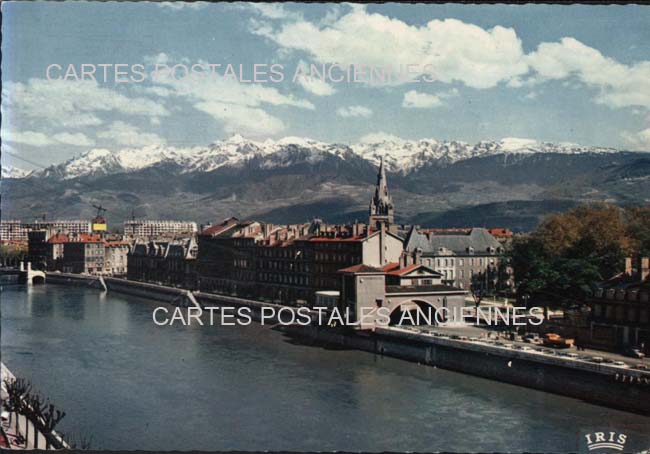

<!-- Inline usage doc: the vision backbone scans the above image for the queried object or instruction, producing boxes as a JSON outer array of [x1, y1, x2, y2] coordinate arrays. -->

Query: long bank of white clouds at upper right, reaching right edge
[[252, 5, 650, 113]]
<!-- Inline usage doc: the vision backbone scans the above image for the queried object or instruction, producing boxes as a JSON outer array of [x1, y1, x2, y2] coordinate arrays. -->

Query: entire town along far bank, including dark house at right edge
[[0, 161, 650, 357]]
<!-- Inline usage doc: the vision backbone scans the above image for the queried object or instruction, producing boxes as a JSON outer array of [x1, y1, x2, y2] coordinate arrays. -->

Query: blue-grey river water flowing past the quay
[[0, 284, 650, 452]]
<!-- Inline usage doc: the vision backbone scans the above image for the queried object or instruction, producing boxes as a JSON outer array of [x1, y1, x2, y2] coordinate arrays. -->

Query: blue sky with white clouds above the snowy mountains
[[1, 2, 650, 169]]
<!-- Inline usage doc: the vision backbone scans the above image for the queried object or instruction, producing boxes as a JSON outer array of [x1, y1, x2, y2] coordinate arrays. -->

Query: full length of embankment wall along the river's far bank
[[47, 273, 650, 415]]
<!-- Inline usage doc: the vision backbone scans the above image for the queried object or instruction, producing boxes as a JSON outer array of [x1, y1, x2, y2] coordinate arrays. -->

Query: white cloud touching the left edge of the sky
[[2, 79, 169, 128]]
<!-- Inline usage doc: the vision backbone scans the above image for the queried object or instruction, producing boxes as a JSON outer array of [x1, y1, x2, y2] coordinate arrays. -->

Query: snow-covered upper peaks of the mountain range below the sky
[[30, 135, 617, 179]]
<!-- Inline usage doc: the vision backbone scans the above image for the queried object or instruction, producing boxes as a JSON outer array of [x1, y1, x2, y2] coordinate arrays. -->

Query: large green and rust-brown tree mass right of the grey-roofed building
[[509, 204, 650, 306]]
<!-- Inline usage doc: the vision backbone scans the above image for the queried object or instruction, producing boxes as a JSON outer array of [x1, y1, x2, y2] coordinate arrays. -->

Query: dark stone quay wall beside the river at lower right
[[287, 326, 650, 415]]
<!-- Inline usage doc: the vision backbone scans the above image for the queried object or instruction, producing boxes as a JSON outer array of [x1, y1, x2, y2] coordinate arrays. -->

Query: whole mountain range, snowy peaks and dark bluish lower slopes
[[2, 135, 650, 230]]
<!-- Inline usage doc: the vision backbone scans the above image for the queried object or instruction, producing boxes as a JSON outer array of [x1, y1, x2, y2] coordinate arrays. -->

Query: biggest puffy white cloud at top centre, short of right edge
[[252, 5, 528, 88]]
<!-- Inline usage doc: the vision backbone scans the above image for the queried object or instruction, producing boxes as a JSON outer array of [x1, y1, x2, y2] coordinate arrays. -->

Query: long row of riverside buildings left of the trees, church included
[[21, 162, 512, 330]]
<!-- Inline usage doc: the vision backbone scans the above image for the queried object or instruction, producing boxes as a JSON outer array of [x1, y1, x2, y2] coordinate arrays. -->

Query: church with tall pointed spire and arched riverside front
[[338, 159, 467, 329]]
